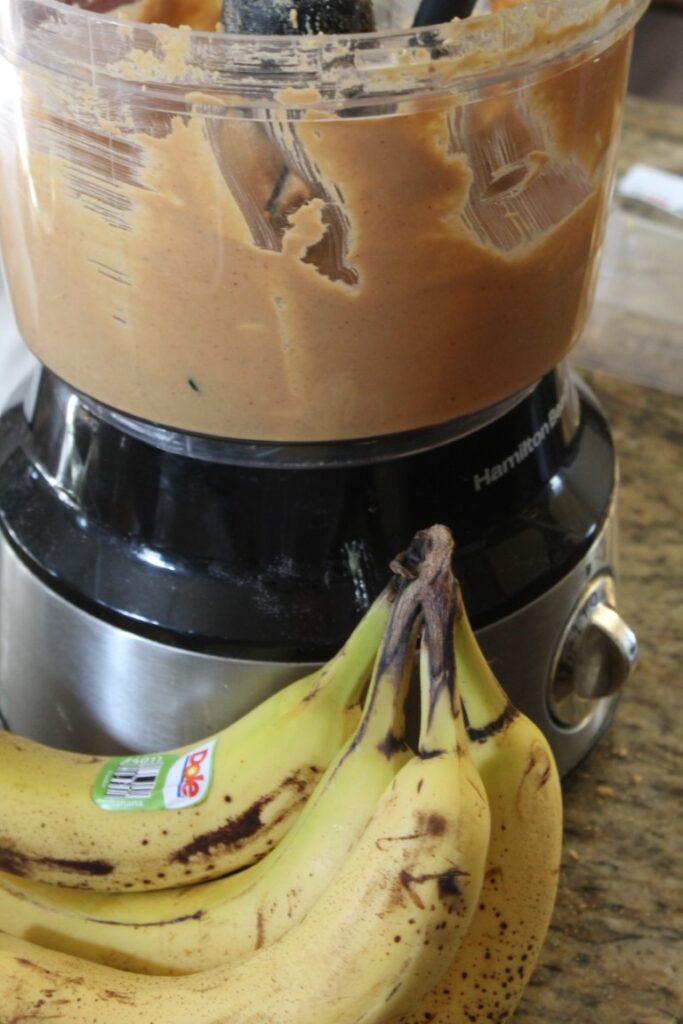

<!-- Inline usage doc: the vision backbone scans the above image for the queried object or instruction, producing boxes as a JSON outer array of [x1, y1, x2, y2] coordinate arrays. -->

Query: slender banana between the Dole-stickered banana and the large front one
[[0, 581, 417, 974]]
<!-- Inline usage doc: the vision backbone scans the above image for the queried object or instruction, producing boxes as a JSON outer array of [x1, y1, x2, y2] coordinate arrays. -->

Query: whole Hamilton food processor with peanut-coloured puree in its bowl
[[0, 0, 644, 772]]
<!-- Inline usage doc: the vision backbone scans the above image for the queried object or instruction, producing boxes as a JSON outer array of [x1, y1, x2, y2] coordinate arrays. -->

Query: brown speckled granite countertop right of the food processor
[[515, 100, 683, 1024]]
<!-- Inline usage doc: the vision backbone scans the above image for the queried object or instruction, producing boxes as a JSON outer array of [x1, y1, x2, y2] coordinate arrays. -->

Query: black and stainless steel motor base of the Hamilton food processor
[[0, 370, 636, 772]]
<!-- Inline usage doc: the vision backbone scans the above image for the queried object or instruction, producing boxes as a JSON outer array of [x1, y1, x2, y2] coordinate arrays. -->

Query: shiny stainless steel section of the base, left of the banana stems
[[0, 529, 313, 754]]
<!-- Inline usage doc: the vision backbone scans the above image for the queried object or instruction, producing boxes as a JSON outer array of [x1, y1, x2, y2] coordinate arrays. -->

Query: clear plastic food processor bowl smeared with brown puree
[[0, 0, 645, 442]]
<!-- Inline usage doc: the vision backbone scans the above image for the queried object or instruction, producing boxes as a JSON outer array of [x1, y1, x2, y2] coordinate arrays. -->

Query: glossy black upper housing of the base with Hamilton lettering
[[0, 370, 614, 662]]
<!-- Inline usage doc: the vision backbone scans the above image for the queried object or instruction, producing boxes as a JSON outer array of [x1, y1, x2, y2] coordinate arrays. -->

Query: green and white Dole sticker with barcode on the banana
[[92, 739, 216, 811]]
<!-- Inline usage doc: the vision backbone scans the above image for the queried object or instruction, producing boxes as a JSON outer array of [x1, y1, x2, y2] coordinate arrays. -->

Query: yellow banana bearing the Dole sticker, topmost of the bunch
[[0, 589, 393, 892]]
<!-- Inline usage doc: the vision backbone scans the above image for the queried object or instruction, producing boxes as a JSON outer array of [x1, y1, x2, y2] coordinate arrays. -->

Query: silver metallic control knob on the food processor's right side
[[549, 573, 638, 727]]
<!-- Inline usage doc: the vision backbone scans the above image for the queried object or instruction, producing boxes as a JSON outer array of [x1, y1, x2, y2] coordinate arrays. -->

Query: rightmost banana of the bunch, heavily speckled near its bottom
[[401, 589, 562, 1024]]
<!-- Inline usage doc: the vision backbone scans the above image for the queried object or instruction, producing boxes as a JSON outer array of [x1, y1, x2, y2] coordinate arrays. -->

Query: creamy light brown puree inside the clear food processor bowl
[[0, 0, 629, 440]]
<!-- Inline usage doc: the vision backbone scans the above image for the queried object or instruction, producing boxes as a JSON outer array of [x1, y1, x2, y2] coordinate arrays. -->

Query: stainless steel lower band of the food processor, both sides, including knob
[[0, 499, 636, 773]]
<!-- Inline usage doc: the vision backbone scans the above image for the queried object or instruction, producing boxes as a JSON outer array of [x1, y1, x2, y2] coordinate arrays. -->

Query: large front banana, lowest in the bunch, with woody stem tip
[[0, 530, 489, 1024]]
